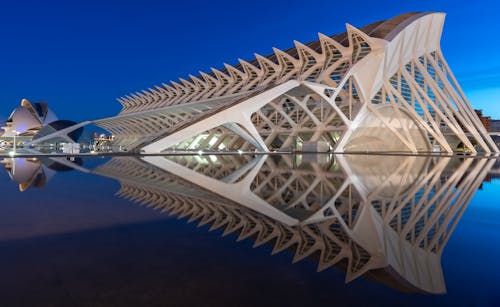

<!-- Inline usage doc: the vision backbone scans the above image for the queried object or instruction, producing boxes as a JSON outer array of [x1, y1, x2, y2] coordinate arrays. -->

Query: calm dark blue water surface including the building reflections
[[0, 155, 500, 306]]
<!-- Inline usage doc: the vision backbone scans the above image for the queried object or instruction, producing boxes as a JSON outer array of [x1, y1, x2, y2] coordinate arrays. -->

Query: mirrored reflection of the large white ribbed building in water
[[89, 155, 495, 294]]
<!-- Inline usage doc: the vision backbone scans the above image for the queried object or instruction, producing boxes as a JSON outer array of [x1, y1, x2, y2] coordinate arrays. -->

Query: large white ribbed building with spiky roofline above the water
[[95, 13, 498, 153]]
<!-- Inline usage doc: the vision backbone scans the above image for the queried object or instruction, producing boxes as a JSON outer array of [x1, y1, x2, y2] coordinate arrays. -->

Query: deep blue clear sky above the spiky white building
[[0, 0, 500, 121]]
